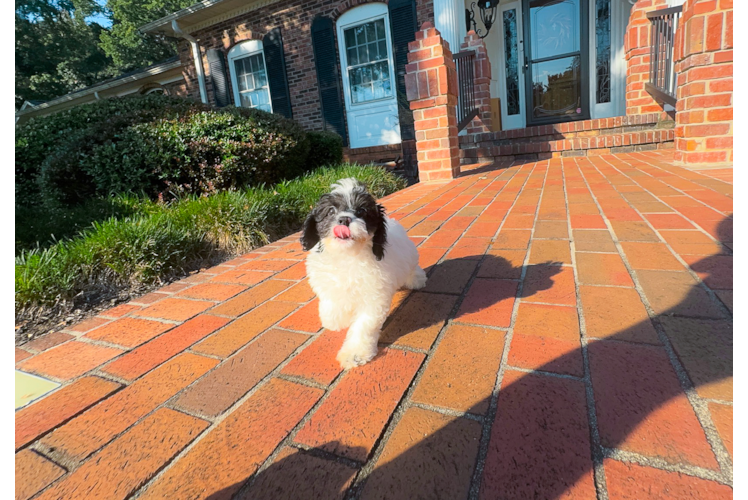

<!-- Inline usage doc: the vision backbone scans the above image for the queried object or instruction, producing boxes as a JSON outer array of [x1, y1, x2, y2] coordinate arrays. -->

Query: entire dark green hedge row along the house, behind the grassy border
[[15, 95, 342, 206]]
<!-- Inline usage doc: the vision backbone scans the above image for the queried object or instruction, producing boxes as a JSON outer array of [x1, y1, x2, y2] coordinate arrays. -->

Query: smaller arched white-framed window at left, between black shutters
[[228, 40, 273, 113]]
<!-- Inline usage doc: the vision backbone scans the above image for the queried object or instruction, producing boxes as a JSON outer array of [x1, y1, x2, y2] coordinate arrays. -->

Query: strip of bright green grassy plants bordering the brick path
[[15, 165, 406, 314]]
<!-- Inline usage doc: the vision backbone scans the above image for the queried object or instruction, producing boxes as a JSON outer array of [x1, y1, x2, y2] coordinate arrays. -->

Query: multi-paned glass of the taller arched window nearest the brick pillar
[[344, 19, 392, 104]]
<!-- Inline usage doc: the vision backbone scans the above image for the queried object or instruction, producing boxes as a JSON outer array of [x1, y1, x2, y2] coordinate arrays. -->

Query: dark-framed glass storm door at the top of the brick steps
[[524, 0, 589, 125]]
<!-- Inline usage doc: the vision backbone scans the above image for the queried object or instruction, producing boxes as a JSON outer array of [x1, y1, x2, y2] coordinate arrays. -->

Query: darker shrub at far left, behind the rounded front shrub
[[15, 94, 207, 205]]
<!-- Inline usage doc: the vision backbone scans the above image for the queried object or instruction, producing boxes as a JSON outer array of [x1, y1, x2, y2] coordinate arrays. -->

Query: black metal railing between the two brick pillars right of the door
[[644, 6, 683, 106]]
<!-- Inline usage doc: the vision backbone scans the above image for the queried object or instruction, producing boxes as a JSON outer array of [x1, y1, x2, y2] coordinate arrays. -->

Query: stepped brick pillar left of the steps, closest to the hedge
[[405, 22, 460, 181]]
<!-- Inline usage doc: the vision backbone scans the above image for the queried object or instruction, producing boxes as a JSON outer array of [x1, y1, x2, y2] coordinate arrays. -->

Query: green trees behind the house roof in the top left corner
[[15, 0, 195, 110]]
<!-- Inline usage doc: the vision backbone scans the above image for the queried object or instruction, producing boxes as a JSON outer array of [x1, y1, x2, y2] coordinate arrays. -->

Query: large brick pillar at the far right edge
[[674, 0, 739, 165]]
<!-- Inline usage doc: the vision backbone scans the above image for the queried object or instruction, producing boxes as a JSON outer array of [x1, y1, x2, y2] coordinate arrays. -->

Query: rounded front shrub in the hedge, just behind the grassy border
[[34, 102, 309, 205]]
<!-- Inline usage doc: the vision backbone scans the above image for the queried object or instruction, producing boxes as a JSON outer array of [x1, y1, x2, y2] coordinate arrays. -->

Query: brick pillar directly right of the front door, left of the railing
[[624, 0, 668, 115]]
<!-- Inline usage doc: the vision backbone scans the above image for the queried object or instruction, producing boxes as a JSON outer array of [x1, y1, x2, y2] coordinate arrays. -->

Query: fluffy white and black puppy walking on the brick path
[[301, 178, 426, 369]]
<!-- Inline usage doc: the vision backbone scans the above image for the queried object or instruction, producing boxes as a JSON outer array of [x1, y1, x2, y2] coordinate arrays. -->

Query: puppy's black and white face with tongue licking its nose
[[301, 179, 387, 260]]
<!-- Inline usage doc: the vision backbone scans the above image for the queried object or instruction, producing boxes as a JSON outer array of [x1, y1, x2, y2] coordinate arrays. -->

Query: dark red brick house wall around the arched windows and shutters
[[179, 0, 434, 135]]
